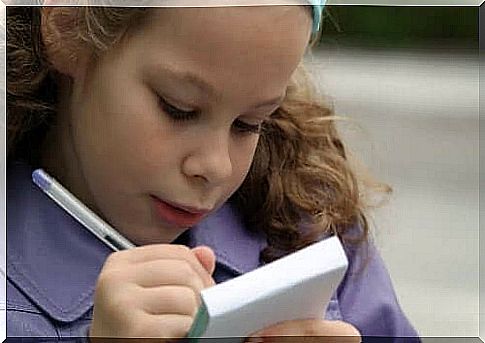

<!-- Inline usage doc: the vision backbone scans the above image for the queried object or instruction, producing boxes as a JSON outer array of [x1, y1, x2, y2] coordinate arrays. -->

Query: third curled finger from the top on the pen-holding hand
[[138, 286, 200, 317]]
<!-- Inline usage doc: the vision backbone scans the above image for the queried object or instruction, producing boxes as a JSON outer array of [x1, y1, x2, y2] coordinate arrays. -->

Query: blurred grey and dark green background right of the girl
[[308, 6, 479, 337]]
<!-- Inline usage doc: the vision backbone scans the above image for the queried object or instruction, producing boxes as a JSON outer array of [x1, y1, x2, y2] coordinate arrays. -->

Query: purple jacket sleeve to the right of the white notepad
[[337, 236, 420, 342]]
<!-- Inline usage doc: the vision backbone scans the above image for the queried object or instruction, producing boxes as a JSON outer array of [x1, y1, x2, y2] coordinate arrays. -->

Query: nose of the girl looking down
[[182, 130, 233, 185]]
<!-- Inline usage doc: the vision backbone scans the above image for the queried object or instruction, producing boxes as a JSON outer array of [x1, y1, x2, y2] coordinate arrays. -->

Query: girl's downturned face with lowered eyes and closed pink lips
[[44, 6, 311, 244]]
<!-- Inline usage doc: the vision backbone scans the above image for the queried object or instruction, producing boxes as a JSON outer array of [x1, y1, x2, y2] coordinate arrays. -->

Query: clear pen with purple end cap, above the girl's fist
[[32, 169, 135, 251]]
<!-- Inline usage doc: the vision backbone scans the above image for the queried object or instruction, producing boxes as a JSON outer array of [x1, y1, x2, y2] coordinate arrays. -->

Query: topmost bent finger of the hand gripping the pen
[[105, 244, 214, 287]]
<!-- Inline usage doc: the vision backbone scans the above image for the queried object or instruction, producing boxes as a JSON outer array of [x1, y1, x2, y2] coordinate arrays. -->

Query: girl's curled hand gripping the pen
[[89, 244, 215, 341]]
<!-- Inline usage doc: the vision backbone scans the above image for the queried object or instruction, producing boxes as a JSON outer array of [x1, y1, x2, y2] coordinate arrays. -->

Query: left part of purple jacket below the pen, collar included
[[6, 164, 110, 337]]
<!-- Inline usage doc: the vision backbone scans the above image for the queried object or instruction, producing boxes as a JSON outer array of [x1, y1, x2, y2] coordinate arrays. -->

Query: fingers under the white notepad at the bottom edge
[[246, 319, 361, 343]]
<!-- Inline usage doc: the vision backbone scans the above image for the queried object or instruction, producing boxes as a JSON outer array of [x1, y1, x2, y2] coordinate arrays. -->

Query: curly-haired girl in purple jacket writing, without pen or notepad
[[7, 2, 416, 342]]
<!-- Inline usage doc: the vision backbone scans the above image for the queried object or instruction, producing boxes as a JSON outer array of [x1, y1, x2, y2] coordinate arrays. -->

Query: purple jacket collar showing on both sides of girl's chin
[[7, 162, 265, 322]]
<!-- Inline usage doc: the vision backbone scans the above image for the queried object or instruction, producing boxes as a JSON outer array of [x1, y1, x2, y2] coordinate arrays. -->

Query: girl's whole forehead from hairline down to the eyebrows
[[116, 6, 312, 104]]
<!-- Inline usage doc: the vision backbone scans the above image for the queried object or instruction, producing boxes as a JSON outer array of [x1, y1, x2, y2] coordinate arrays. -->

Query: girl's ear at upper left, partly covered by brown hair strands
[[41, 7, 88, 78]]
